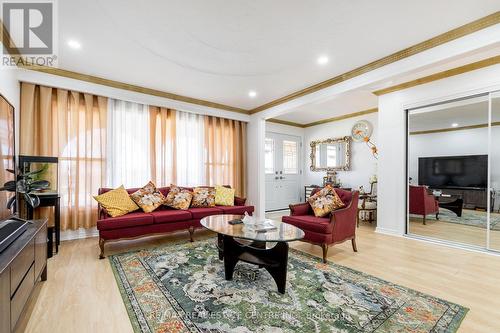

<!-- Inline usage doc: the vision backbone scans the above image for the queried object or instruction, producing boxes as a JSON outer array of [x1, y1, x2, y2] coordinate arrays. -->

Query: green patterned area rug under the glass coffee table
[[110, 239, 468, 333]]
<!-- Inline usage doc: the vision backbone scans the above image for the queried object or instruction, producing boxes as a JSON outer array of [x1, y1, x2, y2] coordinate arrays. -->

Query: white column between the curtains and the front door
[[247, 115, 266, 218]]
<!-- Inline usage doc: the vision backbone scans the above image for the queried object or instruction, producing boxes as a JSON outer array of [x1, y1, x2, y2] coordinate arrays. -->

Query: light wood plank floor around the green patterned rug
[[15, 219, 500, 333]]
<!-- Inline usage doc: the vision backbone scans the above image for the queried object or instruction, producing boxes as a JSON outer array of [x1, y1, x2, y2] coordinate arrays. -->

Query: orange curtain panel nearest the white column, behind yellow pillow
[[205, 116, 247, 196]]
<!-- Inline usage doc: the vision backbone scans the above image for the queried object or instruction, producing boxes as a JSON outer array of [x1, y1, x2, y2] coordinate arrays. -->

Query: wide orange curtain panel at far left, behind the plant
[[20, 82, 107, 230]]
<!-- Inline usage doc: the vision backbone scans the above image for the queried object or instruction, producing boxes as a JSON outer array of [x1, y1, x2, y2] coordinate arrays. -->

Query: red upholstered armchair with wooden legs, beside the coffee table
[[282, 189, 359, 263]]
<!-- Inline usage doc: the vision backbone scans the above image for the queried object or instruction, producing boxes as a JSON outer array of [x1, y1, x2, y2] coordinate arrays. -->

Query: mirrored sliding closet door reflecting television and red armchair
[[407, 93, 494, 249]]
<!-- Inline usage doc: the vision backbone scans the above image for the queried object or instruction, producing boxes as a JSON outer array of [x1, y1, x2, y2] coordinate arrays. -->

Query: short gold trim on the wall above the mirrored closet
[[373, 56, 500, 96]]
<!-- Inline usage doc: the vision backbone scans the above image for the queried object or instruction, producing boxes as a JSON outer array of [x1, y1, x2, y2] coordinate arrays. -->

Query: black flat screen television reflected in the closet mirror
[[418, 155, 488, 189]]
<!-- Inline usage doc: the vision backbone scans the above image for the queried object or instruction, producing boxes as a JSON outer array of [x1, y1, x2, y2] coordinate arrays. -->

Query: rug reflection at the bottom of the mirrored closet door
[[410, 208, 500, 230]]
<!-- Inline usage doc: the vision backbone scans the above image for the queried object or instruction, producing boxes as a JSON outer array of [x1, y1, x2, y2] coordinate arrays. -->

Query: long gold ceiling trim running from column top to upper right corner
[[250, 11, 500, 114]]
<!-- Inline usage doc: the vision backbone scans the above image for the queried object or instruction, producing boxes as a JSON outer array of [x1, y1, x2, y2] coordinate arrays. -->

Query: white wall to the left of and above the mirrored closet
[[377, 65, 500, 235]]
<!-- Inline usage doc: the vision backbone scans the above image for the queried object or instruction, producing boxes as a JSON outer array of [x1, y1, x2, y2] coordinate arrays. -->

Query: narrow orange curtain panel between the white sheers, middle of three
[[149, 106, 177, 186]]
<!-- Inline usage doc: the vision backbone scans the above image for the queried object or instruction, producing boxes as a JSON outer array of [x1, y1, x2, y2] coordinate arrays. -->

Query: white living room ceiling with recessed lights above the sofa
[[58, 0, 500, 109]]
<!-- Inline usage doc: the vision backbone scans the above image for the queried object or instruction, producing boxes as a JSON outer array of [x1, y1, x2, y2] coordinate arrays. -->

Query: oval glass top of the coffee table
[[200, 215, 304, 242]]
